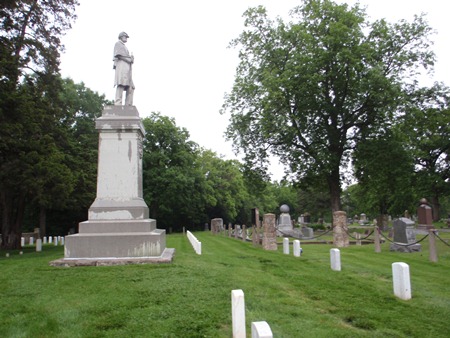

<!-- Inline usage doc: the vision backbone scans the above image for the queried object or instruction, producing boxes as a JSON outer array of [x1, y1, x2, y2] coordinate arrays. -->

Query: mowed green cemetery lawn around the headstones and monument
[[0, 232, 450, 337]]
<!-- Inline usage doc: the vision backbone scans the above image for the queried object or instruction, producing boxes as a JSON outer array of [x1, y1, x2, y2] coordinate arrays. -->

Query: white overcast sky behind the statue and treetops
[[61, 0, 450, 180]]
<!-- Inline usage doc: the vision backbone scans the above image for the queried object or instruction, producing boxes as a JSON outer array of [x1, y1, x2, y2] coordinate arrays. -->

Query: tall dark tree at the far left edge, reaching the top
[[0, 0, 78, 249]]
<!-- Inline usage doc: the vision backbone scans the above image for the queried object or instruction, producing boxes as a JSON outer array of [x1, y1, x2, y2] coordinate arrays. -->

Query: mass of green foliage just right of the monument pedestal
[[143, 113, 250, 231]]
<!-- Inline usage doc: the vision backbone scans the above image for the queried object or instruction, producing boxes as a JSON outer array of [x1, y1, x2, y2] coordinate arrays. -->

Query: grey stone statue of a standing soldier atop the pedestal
[[113, 32, 134, 106]]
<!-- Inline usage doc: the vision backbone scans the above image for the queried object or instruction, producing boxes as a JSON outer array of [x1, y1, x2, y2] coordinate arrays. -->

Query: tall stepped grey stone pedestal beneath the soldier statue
[[50, 106, 174, 266]]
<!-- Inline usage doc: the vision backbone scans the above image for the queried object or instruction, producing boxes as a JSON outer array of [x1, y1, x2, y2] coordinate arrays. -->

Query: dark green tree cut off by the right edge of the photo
[[400, 83, 450, 221]]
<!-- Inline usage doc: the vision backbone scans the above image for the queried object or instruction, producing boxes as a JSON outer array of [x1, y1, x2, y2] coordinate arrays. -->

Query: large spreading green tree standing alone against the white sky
[[223, 0, 434, 211]]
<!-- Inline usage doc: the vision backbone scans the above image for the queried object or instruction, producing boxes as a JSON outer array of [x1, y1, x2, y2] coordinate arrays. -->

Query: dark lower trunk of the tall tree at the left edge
[[0, 191, 25, 250]]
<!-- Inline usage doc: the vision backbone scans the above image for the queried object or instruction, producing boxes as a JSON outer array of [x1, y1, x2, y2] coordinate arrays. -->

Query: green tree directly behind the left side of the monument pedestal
[[39, 79, 108, 235]]
